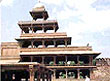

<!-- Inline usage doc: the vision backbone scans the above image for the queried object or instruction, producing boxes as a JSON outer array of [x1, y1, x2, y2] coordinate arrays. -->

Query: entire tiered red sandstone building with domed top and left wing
[[0, 2, 100, 81]]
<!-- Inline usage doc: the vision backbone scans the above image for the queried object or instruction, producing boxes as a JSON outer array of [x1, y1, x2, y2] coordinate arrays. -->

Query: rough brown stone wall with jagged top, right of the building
[[93, 58, 110, 81]]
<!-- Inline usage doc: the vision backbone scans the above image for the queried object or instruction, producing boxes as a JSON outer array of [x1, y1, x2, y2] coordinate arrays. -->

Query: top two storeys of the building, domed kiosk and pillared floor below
[[18, 3, 59, 34]]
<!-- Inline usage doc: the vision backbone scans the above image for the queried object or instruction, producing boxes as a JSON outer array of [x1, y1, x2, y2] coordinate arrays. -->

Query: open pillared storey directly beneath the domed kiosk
[[18, 20, 58, 33]]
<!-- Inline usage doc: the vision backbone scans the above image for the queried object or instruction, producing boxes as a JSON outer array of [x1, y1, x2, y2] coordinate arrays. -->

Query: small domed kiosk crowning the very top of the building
[[30, 3, 48, 20]]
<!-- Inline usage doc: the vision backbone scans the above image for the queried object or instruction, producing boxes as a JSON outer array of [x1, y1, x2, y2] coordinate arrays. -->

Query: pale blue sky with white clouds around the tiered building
[[0, 0, 110, 58]]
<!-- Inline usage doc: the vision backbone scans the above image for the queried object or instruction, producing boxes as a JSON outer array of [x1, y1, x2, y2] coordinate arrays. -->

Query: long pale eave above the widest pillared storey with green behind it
[[20, 51, 101, 55]]
